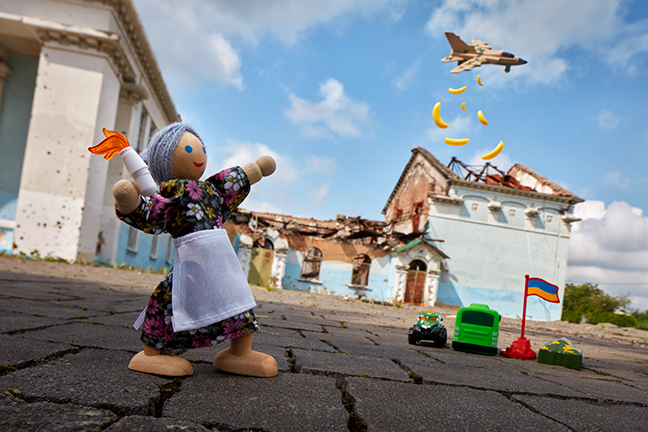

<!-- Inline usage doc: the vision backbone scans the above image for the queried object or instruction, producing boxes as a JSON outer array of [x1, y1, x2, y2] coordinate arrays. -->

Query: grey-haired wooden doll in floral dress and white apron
[[104, 123, 277, 377]]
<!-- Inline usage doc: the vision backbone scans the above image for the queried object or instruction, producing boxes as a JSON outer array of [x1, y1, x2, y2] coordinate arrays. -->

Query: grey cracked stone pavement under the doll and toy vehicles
[[0, 257, 648, 431]]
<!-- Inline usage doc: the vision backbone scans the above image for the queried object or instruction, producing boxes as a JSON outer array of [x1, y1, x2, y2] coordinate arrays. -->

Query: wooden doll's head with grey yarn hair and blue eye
[[141, 122, 207, 184]]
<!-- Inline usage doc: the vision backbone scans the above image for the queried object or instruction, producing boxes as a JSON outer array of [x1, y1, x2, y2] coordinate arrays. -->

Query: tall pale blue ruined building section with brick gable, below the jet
[[383, 147, 582, 321]]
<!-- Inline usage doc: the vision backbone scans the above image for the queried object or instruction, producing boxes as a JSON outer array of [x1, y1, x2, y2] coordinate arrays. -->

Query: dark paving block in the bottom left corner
[[0, 391, 117, 432]]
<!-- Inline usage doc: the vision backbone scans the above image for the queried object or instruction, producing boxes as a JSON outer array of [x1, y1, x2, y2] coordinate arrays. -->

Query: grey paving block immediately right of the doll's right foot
[[293, 350, 411, 381]]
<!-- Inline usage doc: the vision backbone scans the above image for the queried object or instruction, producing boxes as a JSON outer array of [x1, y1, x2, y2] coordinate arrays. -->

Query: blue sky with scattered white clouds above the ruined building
[[134, 0, 648, 309]]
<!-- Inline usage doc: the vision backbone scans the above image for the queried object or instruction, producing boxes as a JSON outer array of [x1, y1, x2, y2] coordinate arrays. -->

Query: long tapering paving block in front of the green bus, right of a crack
[[403, 359, 585, 397]]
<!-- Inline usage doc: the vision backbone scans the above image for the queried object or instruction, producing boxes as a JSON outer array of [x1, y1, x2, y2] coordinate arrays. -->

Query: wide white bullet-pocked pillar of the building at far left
[[14, 44, 120, 261]]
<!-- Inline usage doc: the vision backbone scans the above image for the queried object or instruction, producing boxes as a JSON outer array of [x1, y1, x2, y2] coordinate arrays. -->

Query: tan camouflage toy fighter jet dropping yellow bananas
[[441, 32, 527, 73]]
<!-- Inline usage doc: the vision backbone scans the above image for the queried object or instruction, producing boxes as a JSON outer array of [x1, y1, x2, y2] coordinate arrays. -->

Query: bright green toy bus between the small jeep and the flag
[[452, 303, 502, 355]]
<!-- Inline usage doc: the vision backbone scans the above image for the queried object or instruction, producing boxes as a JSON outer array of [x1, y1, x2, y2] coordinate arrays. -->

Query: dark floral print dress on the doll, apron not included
[[117, 167, 259, 351]]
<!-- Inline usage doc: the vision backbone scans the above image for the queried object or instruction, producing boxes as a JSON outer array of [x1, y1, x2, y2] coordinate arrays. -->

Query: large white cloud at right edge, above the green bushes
[[567, 201, 648, 309]]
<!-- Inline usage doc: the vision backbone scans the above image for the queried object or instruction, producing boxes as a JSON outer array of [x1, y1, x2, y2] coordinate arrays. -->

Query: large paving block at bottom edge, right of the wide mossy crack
[[346, 378, 565, 432]]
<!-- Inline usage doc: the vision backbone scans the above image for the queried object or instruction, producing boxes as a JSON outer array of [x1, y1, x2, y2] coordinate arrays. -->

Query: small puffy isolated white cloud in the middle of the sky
[[285, 78, 369, 138]]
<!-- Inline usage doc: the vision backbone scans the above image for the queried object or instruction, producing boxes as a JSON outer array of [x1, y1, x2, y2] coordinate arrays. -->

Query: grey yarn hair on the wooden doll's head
[[140, 122, 204, 185]]
